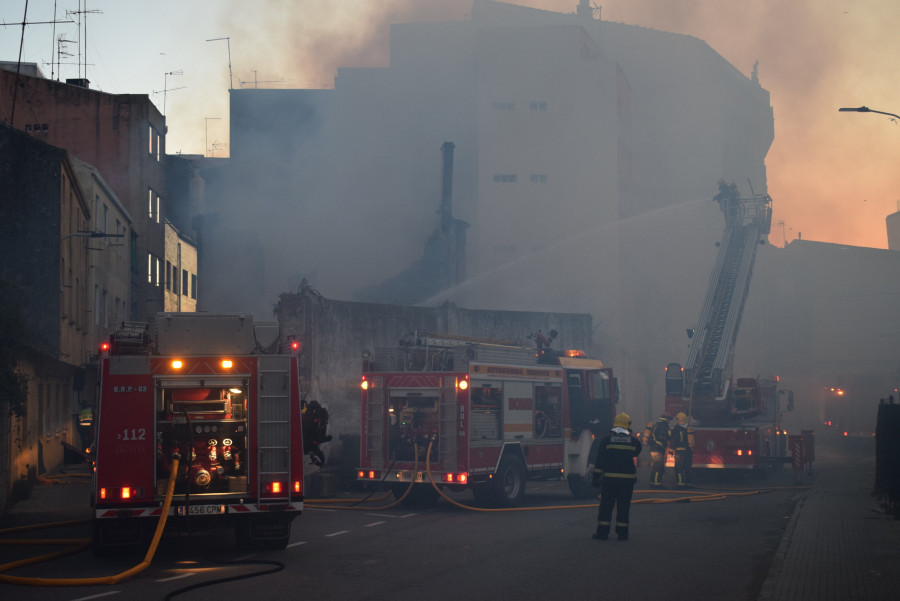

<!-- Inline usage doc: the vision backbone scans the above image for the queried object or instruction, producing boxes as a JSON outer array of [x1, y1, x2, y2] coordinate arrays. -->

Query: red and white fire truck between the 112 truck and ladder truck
[[358, 331, 617, 507]]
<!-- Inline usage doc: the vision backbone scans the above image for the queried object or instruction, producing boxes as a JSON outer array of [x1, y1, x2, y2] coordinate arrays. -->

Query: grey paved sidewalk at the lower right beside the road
[[758, 438, 900, 601]]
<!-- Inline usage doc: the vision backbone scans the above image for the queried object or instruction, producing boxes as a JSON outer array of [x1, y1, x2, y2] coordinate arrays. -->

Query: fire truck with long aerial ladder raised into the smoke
[[665, 181, 786, 470]]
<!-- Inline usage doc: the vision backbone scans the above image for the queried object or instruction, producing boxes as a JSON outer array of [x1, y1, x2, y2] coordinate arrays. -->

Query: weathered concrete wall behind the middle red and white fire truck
[[275, 286, 602, 464]]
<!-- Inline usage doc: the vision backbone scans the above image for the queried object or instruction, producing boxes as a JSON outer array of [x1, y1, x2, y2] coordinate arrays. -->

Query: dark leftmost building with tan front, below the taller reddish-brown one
[[0, 126, 94, 500]]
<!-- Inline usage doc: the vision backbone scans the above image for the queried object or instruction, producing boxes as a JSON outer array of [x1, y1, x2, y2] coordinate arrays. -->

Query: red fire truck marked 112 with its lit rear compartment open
[[91, 313, 304, 551]]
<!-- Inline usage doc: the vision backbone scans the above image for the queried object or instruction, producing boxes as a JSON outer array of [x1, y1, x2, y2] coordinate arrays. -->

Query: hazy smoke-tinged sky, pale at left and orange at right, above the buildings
[[0, 0, 900, 248]]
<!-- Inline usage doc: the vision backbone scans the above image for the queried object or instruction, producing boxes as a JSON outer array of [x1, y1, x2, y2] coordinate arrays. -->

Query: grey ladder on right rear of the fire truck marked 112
[[256, 355, 291, 504]]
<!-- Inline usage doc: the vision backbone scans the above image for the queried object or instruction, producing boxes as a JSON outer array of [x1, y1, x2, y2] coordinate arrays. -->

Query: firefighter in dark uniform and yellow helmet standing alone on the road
[[593, 413, 643, 540]]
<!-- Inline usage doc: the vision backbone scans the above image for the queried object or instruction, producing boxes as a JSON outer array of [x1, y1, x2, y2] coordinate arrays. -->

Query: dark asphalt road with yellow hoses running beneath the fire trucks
[[0, 452, 824, 601]]
